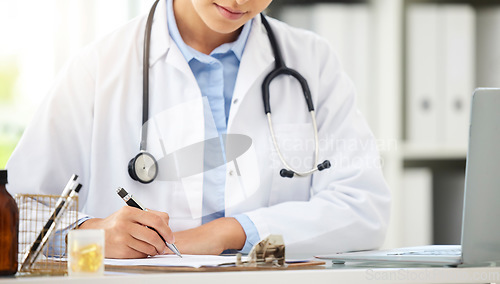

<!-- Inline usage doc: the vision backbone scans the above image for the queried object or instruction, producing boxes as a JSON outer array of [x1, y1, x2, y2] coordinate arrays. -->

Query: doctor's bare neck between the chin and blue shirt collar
[[173, 1, 242, 54]]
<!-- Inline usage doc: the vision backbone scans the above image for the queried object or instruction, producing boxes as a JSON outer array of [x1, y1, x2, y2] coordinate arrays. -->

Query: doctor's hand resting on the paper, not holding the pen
[[171, 218, 246, 255]]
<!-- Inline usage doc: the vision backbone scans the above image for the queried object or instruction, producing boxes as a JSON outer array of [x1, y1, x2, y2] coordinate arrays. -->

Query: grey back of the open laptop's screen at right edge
[[462, 89, 500, 265]]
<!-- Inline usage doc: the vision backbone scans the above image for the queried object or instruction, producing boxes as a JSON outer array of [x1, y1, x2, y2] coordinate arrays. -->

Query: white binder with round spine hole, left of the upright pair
[[406, 3, 440, 147]]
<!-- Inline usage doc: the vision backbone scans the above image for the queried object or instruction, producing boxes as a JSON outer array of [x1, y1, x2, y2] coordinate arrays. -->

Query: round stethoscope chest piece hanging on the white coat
[[128, 151, 158, 184]]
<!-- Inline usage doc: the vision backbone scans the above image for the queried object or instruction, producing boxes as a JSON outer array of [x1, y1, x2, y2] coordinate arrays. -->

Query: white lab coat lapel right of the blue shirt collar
[[228, 16, 274, 127]]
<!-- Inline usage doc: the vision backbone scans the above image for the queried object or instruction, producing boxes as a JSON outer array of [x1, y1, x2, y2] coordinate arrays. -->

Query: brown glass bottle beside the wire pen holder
[[0, 170, 19, 275]]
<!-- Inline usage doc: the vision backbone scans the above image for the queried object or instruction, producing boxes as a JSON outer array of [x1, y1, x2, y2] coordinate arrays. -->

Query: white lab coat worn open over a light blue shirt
[[7, 1, 390, 254]]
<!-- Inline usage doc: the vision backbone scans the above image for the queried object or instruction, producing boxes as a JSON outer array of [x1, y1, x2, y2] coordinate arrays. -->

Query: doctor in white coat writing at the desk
[[7, 0, 390, 258]]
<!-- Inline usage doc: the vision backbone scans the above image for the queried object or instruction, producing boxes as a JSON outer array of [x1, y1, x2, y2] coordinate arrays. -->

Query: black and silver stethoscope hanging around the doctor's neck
[[128, 0, 331, 184]]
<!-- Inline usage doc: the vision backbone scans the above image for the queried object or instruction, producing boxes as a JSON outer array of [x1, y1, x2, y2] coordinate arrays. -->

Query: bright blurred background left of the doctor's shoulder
[[0, 0, 154, 168]]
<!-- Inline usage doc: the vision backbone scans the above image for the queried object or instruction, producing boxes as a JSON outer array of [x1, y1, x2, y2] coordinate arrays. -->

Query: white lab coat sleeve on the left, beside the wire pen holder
[[7, 47, 95, 215]]
